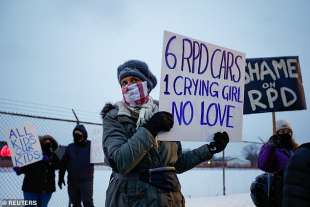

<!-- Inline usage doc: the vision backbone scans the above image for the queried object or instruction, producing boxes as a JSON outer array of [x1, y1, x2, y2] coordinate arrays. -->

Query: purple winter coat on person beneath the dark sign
[[257, 143, 292, 173]]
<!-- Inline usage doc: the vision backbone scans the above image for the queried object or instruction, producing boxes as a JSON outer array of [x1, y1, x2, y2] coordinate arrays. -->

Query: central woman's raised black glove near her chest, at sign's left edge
[[143, 111, 173, 137]]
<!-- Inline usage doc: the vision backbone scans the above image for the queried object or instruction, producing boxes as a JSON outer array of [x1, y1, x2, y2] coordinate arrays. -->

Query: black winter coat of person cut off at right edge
[[282, 143, 310, 207]]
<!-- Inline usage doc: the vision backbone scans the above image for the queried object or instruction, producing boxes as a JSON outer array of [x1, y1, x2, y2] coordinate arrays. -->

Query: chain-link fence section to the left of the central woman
[[0, 112, 110, 207]]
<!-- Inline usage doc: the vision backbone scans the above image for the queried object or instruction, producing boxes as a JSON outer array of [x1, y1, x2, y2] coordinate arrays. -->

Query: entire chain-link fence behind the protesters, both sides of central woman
[[0, 111, 261, 207]]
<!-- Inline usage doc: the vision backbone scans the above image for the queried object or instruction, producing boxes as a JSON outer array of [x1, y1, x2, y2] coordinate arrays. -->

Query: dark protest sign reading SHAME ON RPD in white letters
[[244, 56, 307, 114]]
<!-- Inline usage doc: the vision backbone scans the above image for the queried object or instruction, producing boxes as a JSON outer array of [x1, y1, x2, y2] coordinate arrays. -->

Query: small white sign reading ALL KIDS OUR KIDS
[[5, 124, 43, 167]]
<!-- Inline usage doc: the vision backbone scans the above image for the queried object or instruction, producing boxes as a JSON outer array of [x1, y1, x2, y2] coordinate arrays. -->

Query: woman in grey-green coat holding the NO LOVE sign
[[102, 60, 229, 207]]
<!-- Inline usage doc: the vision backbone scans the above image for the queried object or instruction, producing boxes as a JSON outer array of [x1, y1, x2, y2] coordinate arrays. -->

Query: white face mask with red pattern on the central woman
[[122, 81, 149, 107]]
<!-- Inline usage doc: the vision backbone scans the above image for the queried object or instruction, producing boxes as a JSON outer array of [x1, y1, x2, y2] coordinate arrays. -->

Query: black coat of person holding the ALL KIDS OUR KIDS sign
[[18, 153, 59, 193]]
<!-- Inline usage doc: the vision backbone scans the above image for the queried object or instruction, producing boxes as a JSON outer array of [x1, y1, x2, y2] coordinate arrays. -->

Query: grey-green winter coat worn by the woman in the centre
[[102, 103, 212, 207]]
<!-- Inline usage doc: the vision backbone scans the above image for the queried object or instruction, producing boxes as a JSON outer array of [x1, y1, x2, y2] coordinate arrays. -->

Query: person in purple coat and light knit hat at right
[[257, 120, 298, 207]]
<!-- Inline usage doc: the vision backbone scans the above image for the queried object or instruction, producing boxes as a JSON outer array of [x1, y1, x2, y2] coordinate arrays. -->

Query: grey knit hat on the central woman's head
[[117, 60, 157, 91]]
